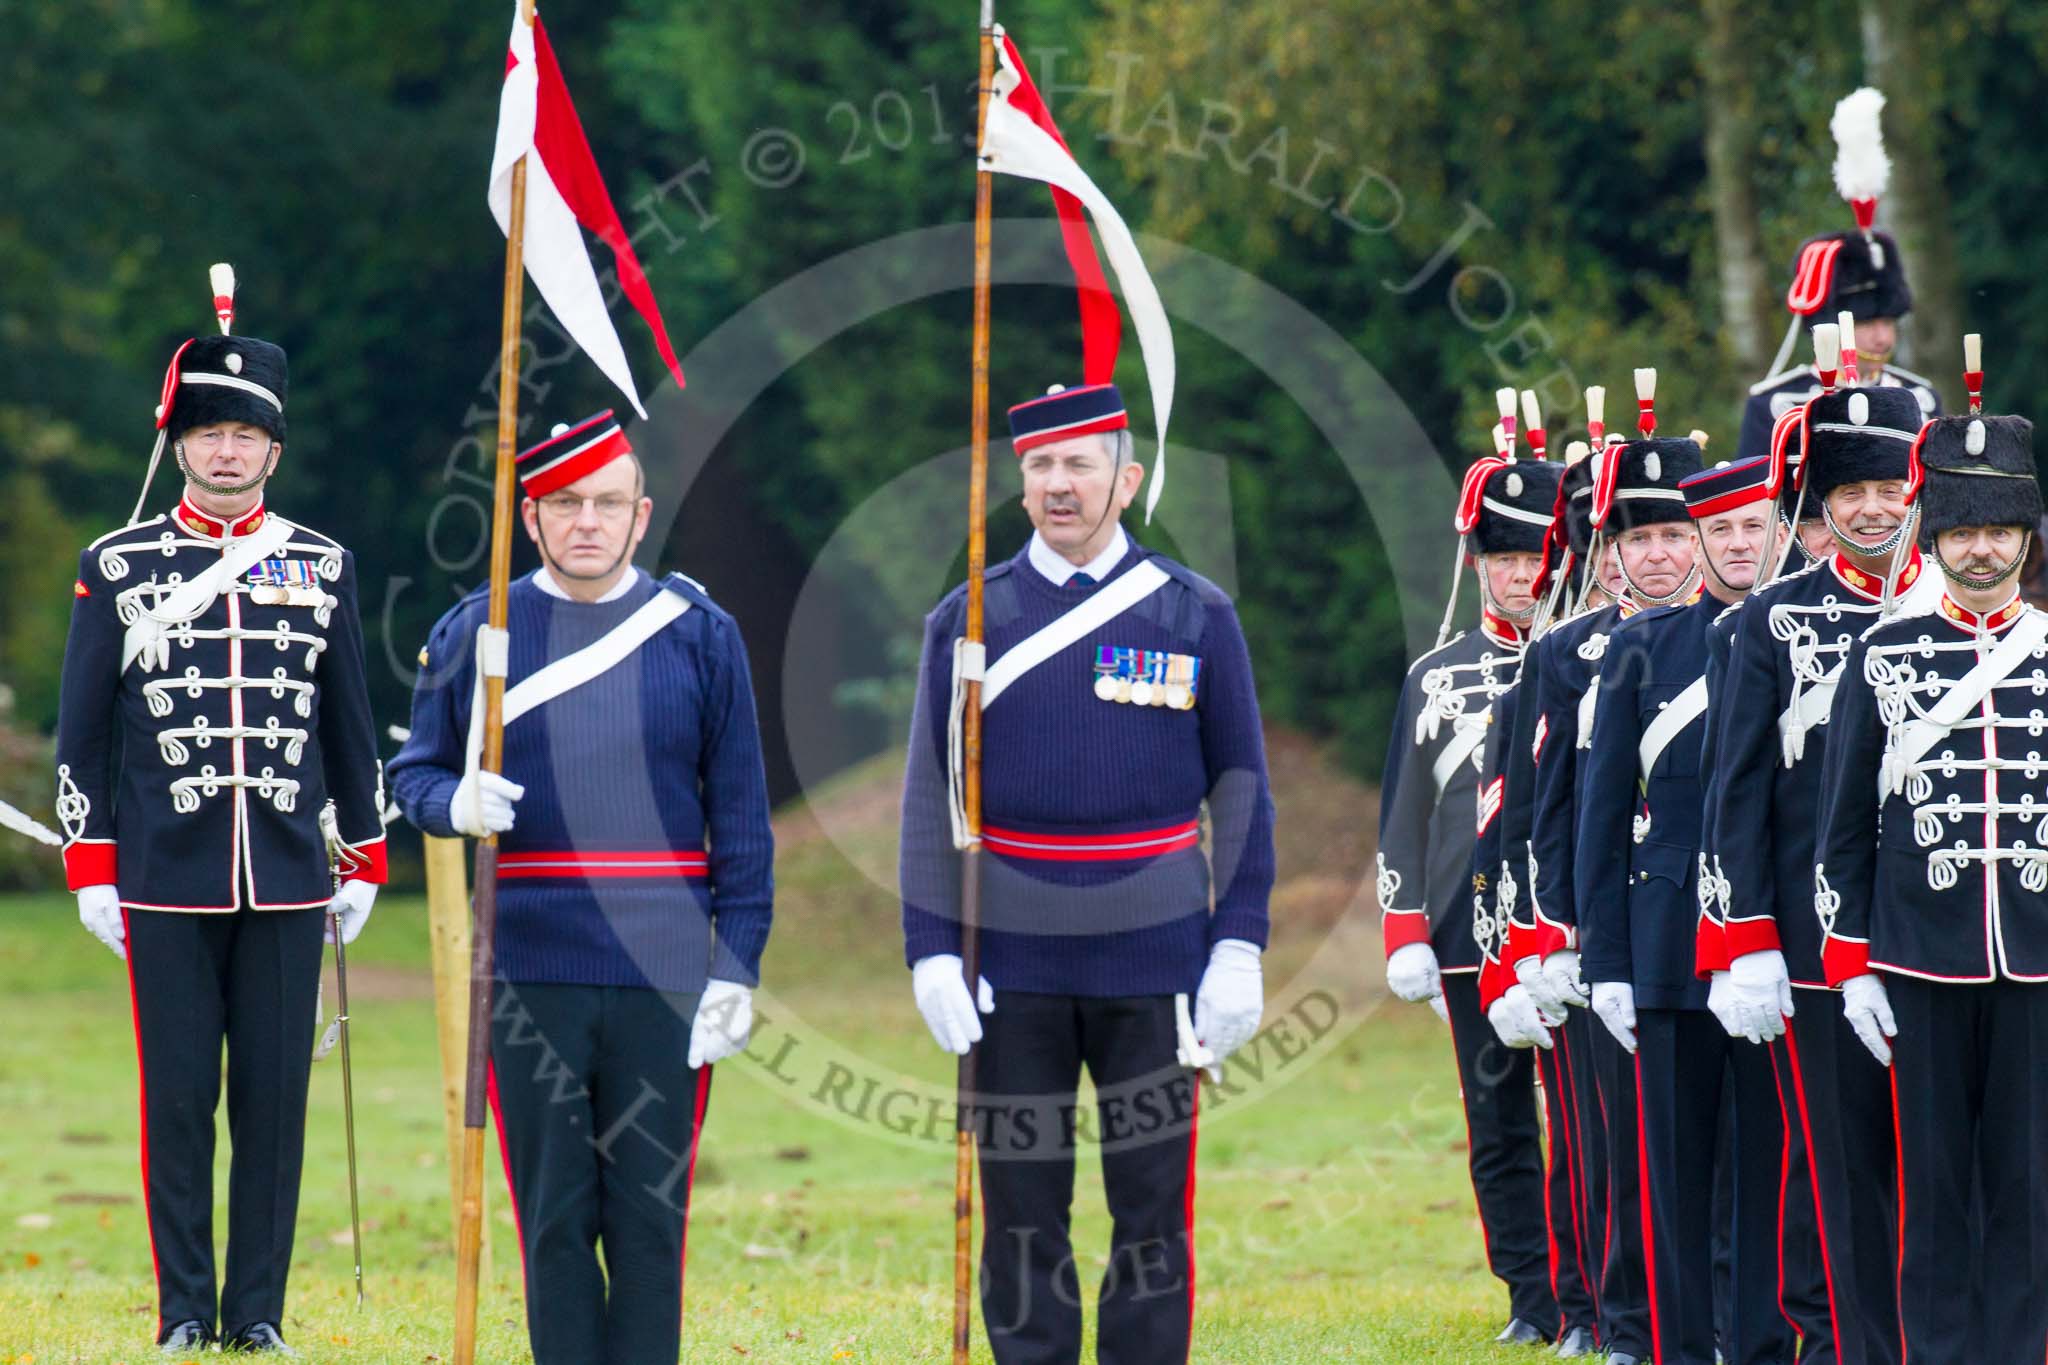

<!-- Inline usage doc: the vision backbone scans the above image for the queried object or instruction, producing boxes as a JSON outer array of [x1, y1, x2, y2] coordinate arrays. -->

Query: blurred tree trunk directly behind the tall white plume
[[1862, 0, 1964, 411]]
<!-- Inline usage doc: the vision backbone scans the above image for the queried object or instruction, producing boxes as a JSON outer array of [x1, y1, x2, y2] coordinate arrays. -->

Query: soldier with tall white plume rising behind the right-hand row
[[1735, 88, 1942, 458]]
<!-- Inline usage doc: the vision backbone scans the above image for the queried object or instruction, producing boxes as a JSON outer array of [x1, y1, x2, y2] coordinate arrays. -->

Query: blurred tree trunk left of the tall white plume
[[1700, 0, 1778, 379]]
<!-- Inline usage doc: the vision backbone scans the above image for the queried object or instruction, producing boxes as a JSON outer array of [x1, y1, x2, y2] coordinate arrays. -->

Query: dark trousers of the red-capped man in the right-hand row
[[1636, 1009, 1796, 1365]]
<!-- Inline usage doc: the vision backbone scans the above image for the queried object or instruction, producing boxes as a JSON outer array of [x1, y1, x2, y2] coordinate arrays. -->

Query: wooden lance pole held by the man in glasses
[[455, 0, 532, 1365]]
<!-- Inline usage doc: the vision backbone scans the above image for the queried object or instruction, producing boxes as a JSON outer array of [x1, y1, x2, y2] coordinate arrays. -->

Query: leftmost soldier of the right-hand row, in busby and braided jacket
[[1378, 431, 1561, 1342]]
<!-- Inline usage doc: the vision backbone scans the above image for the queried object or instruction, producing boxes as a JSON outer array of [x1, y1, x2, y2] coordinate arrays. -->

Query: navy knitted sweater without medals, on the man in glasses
[[389, 575, 774, 993]]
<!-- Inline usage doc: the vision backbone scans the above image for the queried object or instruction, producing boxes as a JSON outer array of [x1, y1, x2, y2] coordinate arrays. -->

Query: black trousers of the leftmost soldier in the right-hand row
[[1444, 972, 1559, 1336]]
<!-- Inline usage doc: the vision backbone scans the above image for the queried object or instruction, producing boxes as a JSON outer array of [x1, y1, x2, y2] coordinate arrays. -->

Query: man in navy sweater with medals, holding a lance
[[901, 385, 1274, 1365]]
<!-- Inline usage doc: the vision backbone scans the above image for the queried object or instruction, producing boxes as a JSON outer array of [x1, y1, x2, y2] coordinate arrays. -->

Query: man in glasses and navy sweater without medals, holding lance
[[391, 411, 774, 1365]]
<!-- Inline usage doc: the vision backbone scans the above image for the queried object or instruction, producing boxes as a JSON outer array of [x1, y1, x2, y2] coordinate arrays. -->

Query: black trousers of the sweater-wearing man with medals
[[975, 990, 1198, 1365]]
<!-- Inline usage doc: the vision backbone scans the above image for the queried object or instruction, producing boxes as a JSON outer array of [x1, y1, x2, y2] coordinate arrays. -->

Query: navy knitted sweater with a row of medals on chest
[[899, 542, 1274, 997]]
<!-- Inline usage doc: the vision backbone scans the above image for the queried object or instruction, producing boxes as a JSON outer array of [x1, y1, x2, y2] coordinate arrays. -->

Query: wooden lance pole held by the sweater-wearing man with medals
[[952, 0, 995, 1365]]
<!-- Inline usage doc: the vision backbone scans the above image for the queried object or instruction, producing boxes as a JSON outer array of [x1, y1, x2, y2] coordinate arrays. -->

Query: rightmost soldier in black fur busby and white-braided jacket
[[1812, 401, 2048, 1365]]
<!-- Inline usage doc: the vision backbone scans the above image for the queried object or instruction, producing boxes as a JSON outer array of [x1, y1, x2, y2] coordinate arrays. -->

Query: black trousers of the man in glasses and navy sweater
[[492, 980, 711, 1365]]
